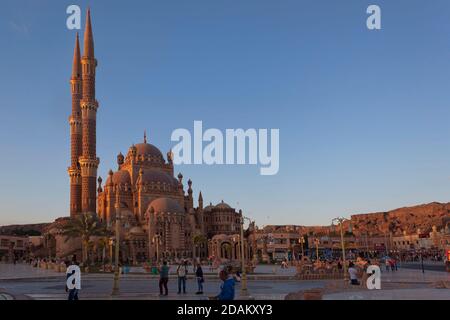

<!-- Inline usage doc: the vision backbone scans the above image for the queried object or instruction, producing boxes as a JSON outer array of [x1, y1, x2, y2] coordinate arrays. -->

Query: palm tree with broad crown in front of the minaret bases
[[63, 213, 107, 263]]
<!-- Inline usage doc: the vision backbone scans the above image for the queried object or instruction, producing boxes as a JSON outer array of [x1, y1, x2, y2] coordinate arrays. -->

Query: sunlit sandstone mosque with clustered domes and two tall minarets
[[68, 11, 242, 261]]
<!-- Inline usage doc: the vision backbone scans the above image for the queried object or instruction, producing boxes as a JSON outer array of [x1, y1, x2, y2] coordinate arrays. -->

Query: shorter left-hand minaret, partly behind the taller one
[[68, 33, 82, 217]]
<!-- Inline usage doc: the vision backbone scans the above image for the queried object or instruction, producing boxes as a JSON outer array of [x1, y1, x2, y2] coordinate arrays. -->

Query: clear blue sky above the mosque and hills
[[0, 0, 450, 225]]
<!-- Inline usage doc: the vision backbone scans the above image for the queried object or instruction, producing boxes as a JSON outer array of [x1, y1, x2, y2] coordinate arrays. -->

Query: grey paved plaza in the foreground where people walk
[[0, 264, 450, 300]]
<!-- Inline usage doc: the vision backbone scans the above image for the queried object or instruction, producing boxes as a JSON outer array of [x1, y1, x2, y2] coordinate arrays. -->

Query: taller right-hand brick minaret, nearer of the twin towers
[[79, 9, 100, 213]]
